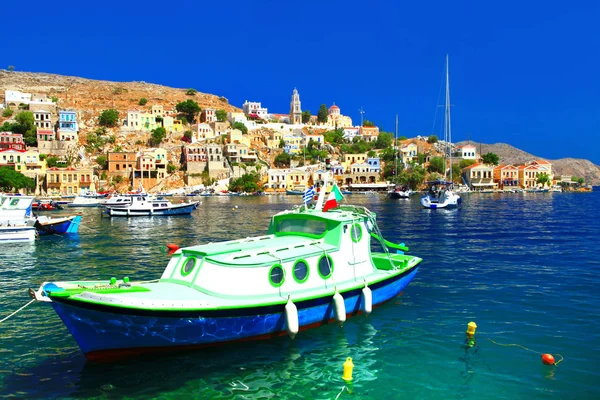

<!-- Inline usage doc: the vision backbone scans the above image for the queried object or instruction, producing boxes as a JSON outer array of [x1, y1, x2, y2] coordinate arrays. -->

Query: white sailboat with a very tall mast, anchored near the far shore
[[421, 54, 462, 209]]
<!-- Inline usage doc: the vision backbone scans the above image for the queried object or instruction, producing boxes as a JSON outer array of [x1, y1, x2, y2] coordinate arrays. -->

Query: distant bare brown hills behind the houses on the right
[[457, 141, 600, 186]]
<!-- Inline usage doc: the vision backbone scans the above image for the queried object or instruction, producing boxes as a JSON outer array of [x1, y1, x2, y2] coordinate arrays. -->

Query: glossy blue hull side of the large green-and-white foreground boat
[[52, 267, 418, 360]]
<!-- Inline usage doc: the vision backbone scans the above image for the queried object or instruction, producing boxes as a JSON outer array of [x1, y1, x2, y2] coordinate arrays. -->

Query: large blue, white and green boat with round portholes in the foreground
[[29, 184, 421, 360]]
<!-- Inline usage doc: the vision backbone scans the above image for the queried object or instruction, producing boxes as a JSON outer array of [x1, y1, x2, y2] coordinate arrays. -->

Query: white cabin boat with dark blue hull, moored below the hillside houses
[[106, 195, 200, 217]]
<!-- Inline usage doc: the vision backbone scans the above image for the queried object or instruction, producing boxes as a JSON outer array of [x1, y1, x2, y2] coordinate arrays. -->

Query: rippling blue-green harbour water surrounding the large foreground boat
[[0, 192, 600, 400]]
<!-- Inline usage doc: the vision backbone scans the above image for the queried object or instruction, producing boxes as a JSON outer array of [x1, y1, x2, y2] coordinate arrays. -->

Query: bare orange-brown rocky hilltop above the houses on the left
[[0, 70, 239, 133]]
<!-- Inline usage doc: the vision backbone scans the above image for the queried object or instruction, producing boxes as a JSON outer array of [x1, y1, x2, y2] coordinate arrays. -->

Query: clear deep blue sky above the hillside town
[[0, 0, 600, 164]]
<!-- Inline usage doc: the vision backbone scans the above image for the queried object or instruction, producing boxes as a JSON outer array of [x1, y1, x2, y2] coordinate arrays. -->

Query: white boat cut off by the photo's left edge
[[0, 195, 35, 243]]
